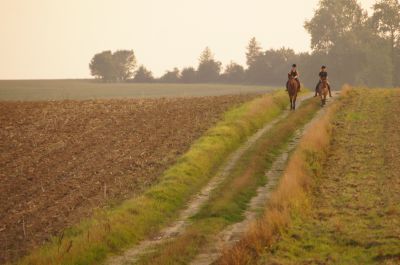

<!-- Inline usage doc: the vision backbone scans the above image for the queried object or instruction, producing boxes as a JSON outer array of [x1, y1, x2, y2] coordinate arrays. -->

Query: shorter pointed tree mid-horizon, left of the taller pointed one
[[197, 47, 221, 82]]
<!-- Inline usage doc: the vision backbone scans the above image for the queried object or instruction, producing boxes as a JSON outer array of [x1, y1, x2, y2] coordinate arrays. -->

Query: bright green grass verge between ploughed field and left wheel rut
[[19, 89, 287, 265]]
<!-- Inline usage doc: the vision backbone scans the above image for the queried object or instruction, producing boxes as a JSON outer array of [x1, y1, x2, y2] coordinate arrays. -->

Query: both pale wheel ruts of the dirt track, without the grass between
[[105, 93, 330, 265]]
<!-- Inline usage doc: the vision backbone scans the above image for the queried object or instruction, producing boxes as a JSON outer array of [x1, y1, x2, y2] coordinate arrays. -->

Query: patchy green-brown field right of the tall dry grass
[[260, 90, 400, 265]]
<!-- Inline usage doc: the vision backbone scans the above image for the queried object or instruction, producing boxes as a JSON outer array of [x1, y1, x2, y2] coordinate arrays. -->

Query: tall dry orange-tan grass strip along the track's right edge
[[218, 87, 350, 265]]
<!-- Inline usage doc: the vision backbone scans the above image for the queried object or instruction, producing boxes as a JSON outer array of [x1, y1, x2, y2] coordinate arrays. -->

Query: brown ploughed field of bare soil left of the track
[[0, 95, 255, 263]]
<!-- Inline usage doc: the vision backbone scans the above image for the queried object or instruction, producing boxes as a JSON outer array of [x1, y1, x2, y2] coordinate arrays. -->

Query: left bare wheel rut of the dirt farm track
[[105, 95, 316, 265]]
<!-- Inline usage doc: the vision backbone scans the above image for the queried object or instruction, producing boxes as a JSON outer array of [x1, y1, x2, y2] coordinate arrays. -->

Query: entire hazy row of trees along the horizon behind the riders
[[89, 0, 400, 87]]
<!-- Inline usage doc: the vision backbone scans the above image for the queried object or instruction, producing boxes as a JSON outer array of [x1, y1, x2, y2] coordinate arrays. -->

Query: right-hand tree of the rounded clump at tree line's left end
[[112, 50, 136, 81]]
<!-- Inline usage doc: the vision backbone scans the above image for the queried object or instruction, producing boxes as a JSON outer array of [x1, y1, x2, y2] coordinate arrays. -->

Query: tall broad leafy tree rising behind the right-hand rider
[[305, 0, 372, 87]]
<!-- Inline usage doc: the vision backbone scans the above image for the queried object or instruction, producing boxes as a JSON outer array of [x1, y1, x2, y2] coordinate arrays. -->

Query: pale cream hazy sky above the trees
[[0, 0, 374, 79]]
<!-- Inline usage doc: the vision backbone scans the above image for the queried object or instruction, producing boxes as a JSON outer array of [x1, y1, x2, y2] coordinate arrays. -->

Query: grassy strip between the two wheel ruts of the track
[[139, 95, 320, 265]]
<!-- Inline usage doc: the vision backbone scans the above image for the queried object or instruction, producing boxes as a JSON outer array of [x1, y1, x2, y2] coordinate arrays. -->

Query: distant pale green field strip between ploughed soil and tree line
[[0, 80, 274, 101]]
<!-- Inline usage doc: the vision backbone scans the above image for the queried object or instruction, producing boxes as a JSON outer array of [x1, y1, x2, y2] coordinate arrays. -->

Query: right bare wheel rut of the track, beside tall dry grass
[[190, 93, 333, 265]]
